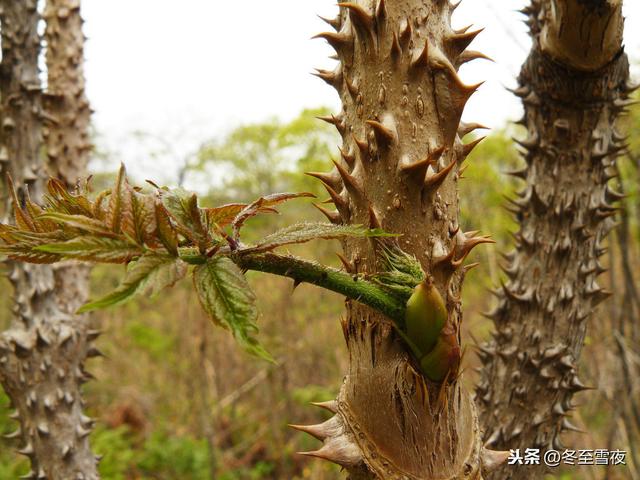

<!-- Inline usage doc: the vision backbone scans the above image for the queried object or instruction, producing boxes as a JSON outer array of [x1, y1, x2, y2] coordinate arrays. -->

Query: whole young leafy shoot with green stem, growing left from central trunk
[[0, 167, 410, 360]]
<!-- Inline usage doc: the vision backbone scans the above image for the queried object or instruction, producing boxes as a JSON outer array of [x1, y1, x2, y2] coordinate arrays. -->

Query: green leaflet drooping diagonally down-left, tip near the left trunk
[[78, 253, 188, 313]]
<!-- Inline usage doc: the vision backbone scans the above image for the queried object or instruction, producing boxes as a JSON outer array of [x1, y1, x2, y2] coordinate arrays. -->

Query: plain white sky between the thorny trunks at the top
[[83, 0, 640, 182]]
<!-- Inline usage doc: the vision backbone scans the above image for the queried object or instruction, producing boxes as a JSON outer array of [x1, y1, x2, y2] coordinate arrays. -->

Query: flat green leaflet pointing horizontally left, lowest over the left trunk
[[33, 235, 143, 263]]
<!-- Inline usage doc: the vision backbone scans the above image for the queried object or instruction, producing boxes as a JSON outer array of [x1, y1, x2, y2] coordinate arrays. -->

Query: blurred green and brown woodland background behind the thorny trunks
[[0, 98, 640, 480]]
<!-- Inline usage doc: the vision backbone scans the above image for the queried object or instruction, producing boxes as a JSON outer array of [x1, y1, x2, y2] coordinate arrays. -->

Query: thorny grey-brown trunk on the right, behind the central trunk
[[477, 0, 630, 479]]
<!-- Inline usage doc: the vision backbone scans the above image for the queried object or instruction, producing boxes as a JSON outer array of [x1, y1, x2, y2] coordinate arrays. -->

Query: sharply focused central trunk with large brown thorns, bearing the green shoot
[[298, 0, 504, 480]]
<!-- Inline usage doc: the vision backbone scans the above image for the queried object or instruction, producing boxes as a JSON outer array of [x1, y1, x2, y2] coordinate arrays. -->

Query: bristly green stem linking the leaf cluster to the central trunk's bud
[[232, 253, 405, 322]]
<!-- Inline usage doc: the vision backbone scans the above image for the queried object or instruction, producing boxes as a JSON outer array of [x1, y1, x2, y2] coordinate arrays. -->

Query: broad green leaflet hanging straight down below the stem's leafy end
[[193, 256, 274, 362]]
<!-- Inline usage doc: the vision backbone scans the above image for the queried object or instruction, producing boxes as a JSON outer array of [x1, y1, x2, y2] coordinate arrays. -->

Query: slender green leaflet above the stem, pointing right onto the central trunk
[[246, 222, 395, 252]]
